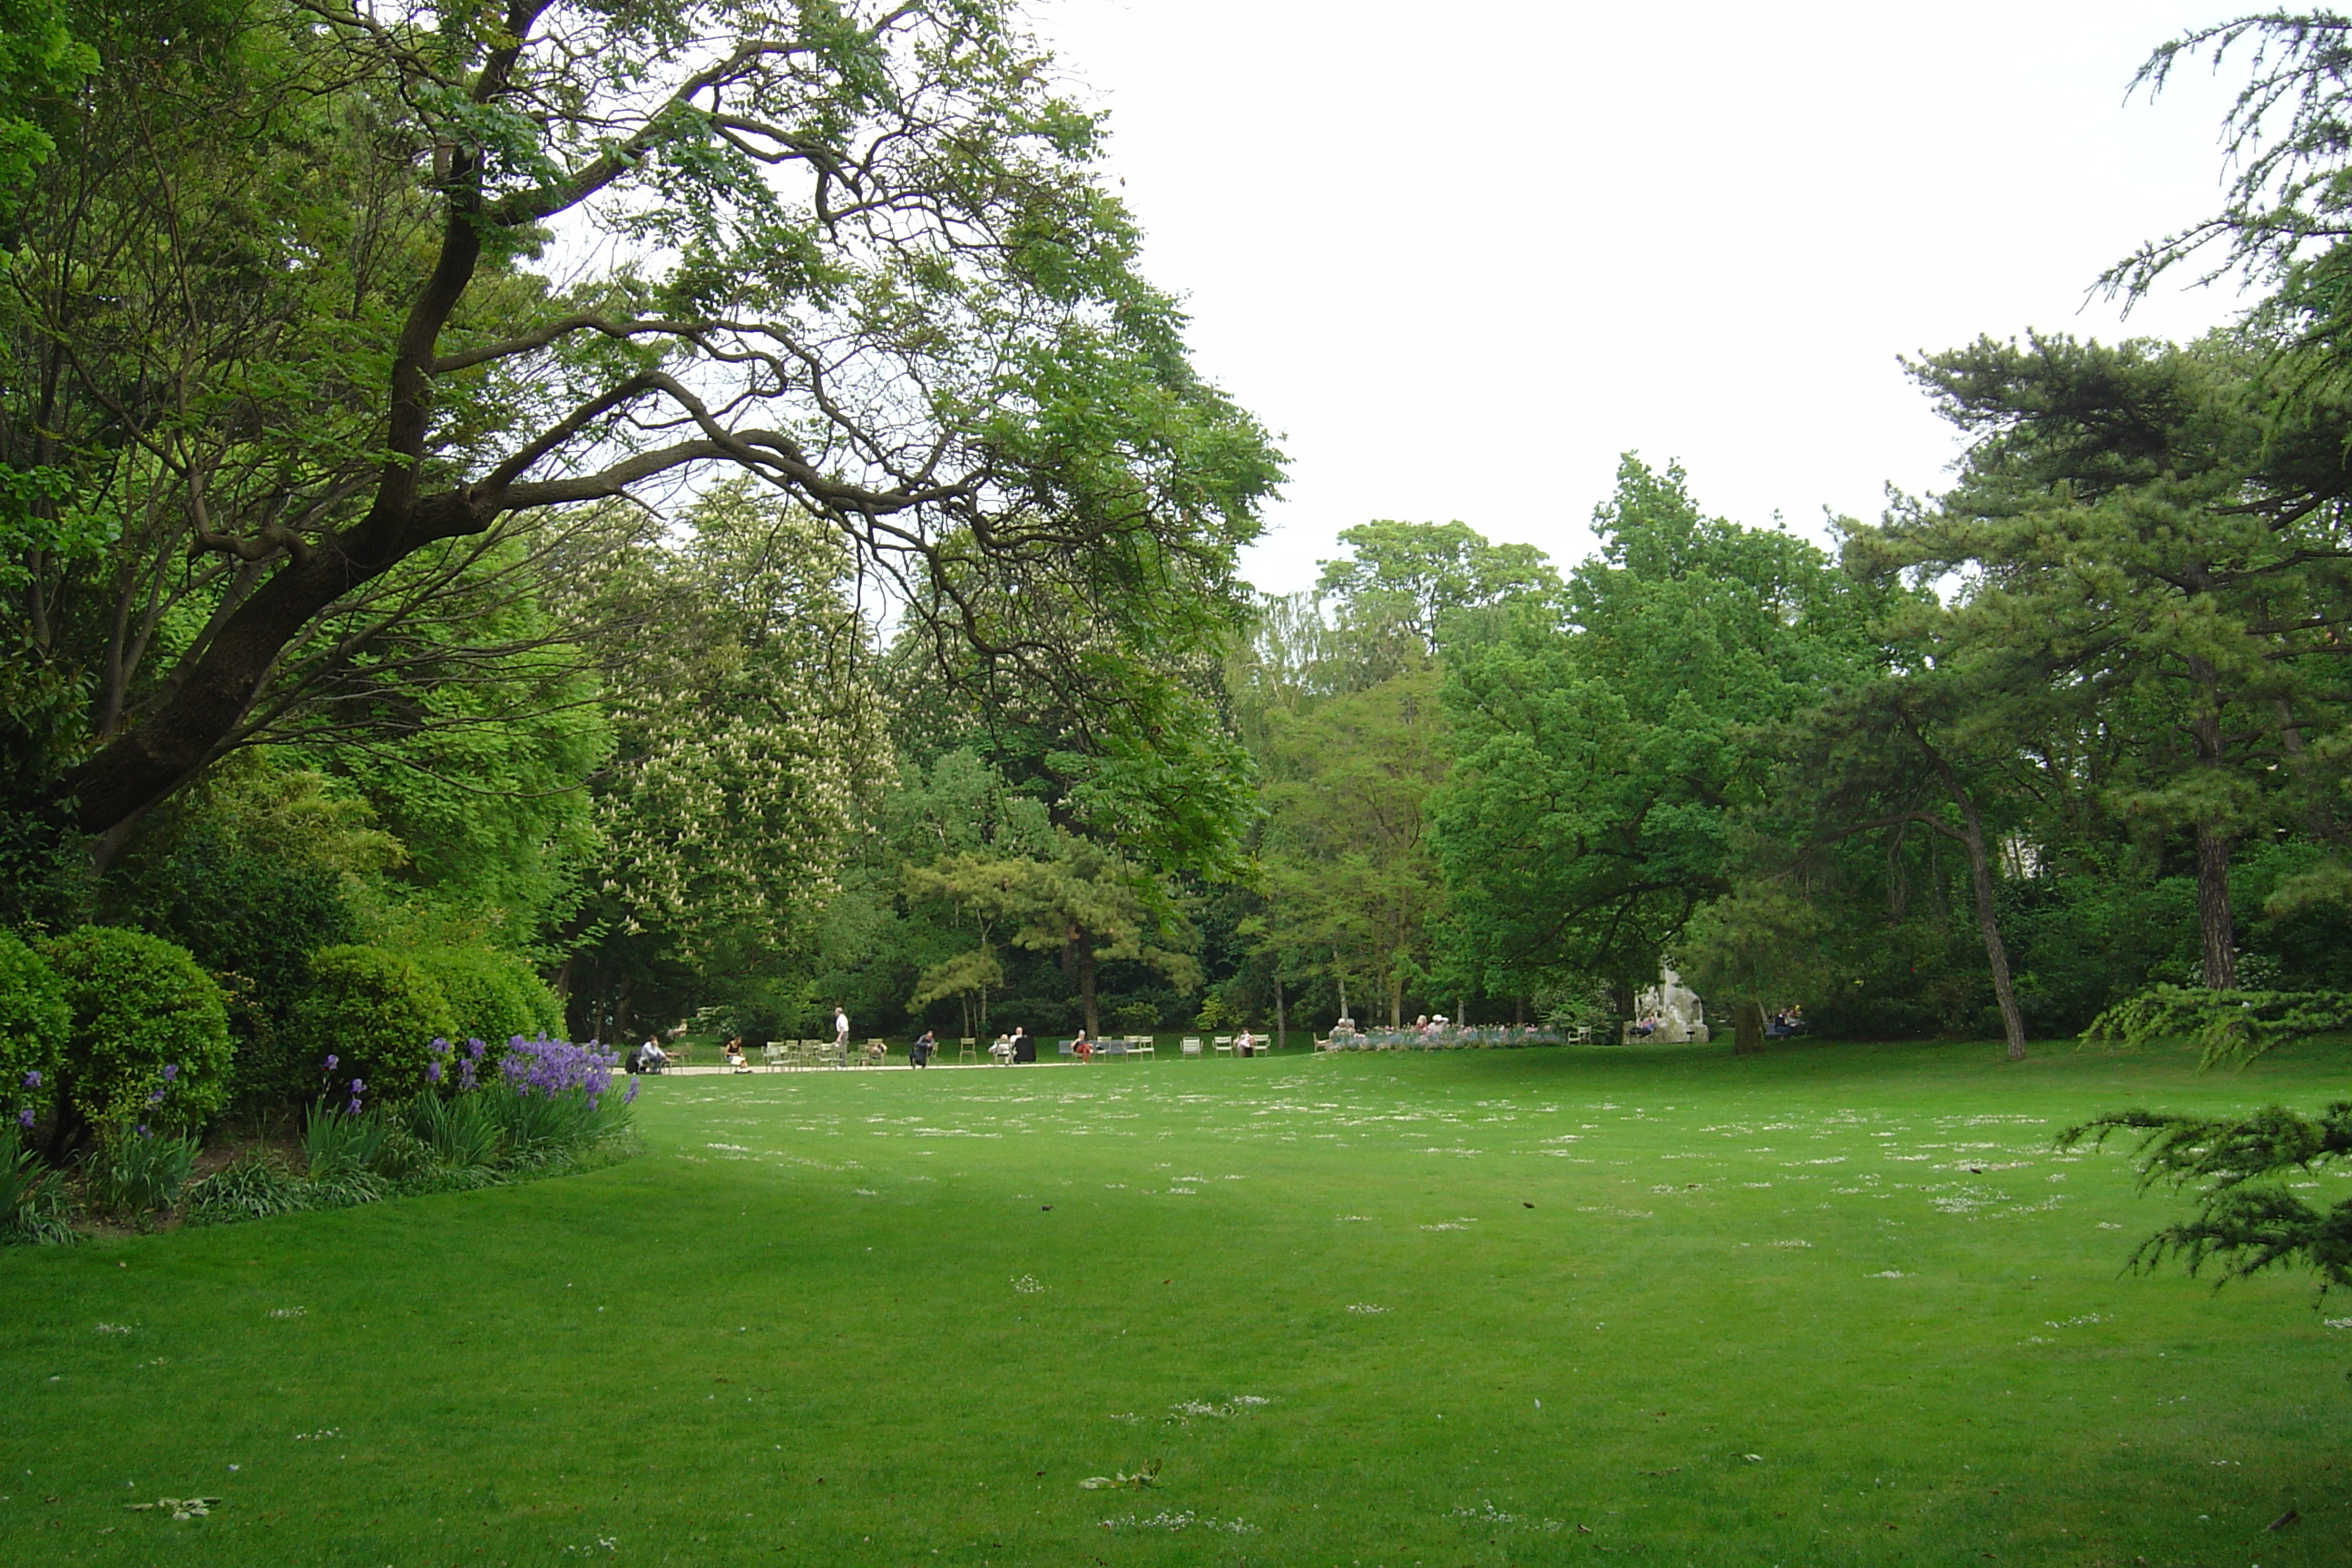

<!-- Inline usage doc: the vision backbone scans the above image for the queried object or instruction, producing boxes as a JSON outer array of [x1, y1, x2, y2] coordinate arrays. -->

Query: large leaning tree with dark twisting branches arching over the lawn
[[0, 0, 1277, 860]]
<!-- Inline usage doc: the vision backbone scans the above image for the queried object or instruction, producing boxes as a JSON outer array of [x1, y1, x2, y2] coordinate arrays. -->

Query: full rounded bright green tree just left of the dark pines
[[1435, 456, 1863, 1005]]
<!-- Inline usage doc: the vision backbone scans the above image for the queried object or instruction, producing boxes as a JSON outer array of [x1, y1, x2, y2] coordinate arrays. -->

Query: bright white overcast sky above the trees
[[1033, 0, 2251, 593]]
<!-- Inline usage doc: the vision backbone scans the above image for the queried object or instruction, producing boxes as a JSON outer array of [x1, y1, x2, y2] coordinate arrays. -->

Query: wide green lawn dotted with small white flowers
[[0, 1044, 2352, 1568]]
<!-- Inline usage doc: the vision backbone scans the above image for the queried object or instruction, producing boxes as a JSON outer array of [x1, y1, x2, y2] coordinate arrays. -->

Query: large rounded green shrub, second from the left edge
[[40, 926, 233, 1129]]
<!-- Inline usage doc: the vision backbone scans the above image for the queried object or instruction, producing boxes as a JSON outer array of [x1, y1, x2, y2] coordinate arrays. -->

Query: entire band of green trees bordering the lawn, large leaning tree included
[[14, 0, 2352, 1081]]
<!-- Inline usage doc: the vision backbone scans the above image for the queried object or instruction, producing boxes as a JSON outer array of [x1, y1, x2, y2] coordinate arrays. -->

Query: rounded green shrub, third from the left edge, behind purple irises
[[287, 945, 456, 1102]]
